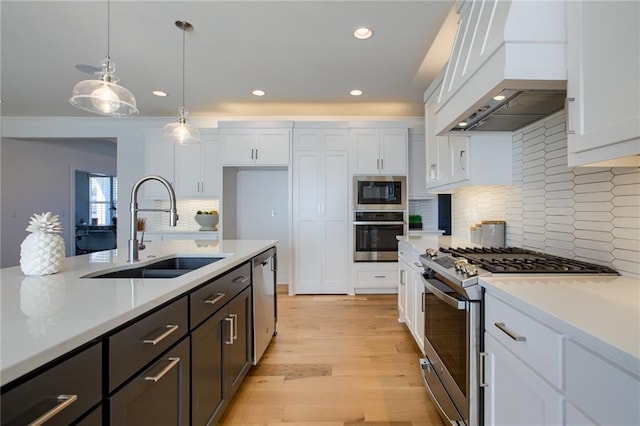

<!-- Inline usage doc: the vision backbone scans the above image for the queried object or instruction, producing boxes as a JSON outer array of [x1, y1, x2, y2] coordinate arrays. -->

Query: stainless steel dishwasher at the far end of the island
[[252, 247, 278, 365]]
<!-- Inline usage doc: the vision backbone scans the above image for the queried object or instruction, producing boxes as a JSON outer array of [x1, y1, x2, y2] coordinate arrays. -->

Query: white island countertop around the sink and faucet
[[0, 240, 277, 385]]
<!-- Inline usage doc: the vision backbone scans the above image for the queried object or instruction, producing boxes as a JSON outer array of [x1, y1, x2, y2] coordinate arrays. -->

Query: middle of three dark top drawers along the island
[[109, 297, 188, 392]]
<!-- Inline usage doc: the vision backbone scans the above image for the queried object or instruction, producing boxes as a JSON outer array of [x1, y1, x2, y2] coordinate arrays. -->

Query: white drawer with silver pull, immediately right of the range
[[485, 293, 563, 389]]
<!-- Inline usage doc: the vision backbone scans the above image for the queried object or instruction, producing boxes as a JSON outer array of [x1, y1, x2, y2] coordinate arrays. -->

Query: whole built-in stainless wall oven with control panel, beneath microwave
[[353, 211, 407, 262]]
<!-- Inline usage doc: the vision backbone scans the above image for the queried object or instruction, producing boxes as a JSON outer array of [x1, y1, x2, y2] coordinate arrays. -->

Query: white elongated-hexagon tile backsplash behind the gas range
[[452, 111, 640, 278]]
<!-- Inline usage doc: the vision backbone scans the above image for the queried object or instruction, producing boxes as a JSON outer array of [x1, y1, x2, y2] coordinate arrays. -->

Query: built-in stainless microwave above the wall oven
[[353, 176, 407, 210]]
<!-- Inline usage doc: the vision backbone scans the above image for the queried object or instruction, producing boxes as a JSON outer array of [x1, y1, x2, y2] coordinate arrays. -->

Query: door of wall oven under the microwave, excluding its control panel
[[353, 221, 405, 262]]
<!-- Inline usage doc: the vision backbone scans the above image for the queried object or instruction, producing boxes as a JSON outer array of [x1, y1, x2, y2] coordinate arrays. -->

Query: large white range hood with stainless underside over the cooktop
[[432, 0, 567, 134]]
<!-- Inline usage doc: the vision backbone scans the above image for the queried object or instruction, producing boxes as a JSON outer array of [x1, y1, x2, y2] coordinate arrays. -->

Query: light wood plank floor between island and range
[[220, 290, 441, 426]]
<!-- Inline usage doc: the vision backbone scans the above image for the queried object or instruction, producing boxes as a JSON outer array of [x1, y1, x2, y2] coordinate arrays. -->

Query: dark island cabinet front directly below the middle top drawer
[[109, 337, 190, 426]]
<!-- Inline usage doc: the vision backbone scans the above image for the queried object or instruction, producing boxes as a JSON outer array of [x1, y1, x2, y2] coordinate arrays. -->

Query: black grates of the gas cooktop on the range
[[440, 247, 618, 275]]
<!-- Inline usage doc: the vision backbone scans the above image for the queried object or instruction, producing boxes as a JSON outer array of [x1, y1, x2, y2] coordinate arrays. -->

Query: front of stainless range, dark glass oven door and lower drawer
[[420, 276, 480, 425]]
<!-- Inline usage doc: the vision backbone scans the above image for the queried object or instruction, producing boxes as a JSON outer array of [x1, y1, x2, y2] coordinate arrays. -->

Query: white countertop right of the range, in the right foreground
[[480, 275, 640, 375]]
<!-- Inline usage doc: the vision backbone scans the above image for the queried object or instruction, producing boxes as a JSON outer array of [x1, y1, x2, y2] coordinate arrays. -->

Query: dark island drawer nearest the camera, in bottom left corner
[[1, 344, 102, 426]]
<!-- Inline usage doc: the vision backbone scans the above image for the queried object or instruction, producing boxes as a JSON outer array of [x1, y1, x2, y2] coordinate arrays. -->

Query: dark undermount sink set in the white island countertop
[[82, 257, 224, 278]]
